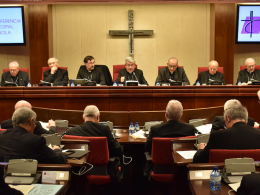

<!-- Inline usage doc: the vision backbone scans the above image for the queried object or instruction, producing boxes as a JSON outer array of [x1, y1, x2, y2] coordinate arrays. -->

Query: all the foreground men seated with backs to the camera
[[0, 97, 260, 194]]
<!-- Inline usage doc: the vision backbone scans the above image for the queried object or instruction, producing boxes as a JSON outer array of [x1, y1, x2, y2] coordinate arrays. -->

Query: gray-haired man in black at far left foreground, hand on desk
[[0, 107, 67, 164]]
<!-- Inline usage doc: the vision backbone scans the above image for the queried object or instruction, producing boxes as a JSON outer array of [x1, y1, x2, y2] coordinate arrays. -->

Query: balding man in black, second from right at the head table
[[194, 60, 225, 85]]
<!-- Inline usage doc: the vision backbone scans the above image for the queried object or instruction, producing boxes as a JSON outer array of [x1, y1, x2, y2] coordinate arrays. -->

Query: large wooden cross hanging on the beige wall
[[109, 10, 153, 57]]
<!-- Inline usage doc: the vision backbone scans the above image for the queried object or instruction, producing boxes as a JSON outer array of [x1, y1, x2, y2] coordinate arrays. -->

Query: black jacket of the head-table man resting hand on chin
[[43, 68, 69, 86]]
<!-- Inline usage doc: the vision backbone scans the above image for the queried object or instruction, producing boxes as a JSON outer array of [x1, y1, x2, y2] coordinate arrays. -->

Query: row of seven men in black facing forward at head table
[[1, 56, 260, 86]]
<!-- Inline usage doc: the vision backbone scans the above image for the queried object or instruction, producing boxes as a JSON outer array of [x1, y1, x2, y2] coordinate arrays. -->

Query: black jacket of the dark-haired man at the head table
[[77, 66, 106, 85]]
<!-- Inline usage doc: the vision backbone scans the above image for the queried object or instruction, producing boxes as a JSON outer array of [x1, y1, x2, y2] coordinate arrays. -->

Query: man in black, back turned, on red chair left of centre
[[66, 105, 123, 157]]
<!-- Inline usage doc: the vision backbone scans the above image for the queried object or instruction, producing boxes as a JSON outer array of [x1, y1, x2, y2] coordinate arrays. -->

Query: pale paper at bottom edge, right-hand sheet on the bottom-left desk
[[28, 184, 63, 195]]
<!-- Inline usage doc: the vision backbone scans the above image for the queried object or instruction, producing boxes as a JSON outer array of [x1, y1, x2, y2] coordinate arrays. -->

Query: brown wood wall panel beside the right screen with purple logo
[[215, 3, 235, 84]]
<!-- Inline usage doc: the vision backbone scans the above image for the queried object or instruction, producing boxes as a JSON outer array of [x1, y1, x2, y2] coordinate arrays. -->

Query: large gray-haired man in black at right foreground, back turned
[[193, 106, 260, 163]]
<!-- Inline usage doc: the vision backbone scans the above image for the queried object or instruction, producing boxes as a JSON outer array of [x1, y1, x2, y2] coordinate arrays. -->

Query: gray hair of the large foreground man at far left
[[12, 107, 37, 127]]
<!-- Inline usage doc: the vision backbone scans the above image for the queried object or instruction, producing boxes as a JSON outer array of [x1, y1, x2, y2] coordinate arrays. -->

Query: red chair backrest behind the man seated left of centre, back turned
[[63, 135, 109, 165]]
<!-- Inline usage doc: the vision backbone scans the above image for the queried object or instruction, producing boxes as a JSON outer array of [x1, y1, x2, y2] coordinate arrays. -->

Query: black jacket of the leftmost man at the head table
[[1, 70, 29, 86]]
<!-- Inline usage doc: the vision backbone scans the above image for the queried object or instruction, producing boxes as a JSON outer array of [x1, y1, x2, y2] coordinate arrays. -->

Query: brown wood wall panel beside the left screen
[[28, 5, 49, 84]]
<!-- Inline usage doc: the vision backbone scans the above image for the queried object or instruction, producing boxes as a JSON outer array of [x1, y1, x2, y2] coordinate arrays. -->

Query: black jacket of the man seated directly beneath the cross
[[116, 68, 148, 85]]
